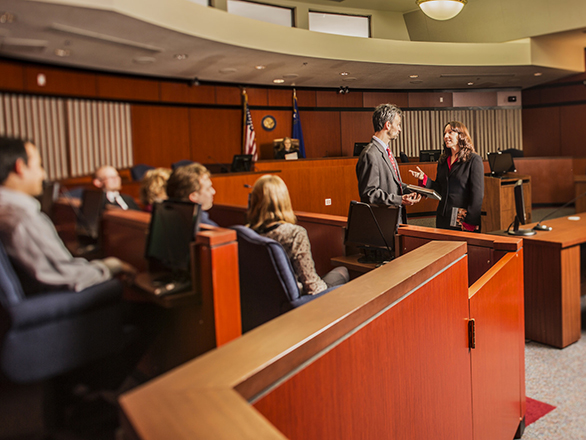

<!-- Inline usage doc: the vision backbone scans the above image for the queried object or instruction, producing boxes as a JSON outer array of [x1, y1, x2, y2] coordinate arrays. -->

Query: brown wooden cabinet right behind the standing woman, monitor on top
[[482, 173, 531, 232]]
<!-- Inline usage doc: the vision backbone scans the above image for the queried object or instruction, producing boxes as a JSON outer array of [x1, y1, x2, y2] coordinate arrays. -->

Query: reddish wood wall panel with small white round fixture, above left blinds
[[24, 66, 97, 97]]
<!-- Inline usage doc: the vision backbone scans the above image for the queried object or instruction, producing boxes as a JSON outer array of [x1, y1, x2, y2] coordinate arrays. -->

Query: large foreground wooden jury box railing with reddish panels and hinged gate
[[120, 241, 525, 440]]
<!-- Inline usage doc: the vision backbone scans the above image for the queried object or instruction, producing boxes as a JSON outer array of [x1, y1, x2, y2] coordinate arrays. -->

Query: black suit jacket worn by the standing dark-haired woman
[[425, 154, 484, 230]]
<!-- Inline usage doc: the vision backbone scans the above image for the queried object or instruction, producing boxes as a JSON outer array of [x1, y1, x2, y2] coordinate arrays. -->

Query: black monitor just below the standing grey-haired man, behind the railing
[[344, 201, 401, 264]]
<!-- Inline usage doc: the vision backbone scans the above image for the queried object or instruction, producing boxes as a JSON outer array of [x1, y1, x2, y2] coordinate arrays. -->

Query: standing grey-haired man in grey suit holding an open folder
[[356, 104, 421, 211]]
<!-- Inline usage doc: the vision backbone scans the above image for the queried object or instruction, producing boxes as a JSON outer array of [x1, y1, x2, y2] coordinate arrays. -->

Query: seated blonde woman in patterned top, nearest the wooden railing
[[248, 175, 350, 295]]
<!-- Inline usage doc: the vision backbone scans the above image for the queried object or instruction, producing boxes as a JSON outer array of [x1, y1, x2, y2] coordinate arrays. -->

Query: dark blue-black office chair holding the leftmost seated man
[[0, 243, 128, 438]]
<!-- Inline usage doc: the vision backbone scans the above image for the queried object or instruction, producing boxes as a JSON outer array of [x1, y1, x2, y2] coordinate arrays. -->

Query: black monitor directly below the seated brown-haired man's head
[[145, 200, 201, 273]]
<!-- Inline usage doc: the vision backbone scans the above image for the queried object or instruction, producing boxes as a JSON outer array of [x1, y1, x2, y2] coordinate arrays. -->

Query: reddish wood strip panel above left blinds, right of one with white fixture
[[98, 75, 160, 101]]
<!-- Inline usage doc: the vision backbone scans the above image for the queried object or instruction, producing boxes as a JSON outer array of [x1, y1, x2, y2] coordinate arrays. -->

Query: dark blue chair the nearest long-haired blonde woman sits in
[[232, 225, 338, 333]]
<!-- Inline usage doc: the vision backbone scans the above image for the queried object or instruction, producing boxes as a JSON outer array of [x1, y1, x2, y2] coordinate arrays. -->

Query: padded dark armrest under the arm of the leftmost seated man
[[9, 279, 122, 329]]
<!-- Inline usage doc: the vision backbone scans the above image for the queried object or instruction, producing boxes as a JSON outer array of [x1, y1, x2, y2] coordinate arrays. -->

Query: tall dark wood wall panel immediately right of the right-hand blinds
[[522, 107, 561, 157]]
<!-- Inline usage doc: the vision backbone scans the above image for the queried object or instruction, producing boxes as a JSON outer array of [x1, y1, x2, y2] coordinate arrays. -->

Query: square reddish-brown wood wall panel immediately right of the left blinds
[[131, 105, 191, 167]]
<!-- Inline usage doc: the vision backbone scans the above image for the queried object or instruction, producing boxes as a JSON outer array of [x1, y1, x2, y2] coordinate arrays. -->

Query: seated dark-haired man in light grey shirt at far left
[[0, 137, 135, 293]]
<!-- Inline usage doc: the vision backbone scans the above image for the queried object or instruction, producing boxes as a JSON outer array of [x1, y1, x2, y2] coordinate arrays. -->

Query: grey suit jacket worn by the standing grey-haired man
[[356, 139, 410, 206]]
